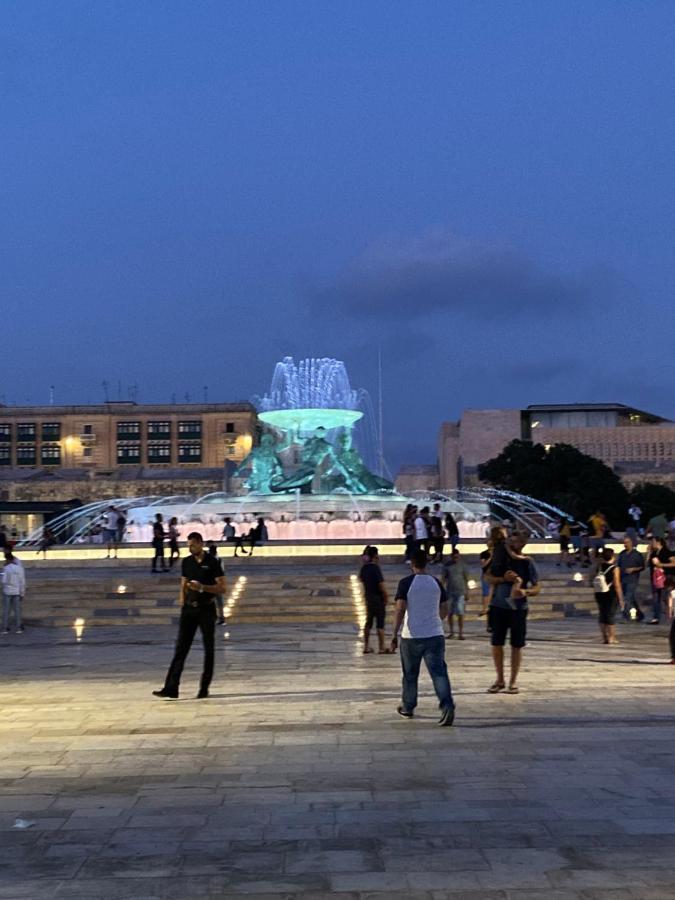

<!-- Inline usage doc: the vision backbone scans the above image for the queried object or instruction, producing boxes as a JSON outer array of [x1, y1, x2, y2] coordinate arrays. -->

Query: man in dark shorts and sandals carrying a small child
[[488, 533, 540, 694]]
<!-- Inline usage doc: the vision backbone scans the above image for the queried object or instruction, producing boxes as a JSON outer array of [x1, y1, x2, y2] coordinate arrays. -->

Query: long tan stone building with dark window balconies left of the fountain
[[0, 401, 257, 532]]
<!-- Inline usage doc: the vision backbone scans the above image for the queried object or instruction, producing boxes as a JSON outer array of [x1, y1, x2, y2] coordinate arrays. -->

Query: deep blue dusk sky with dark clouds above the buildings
[[0, 0, 675, 471]]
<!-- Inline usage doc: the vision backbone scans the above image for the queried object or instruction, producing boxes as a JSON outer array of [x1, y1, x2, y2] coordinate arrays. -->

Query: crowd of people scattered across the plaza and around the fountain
[[2, 503, 675, 726]]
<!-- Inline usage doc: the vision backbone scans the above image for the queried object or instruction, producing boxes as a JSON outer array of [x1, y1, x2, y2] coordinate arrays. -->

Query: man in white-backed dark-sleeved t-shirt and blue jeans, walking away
[[391, 549, 455, 725]]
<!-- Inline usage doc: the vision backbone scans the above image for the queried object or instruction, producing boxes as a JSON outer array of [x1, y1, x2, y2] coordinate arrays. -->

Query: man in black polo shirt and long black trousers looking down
[[152, 531, 225, 700]]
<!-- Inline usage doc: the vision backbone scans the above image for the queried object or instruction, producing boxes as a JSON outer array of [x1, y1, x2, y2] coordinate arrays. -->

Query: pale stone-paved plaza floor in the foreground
[[0, 619, 675, 900]]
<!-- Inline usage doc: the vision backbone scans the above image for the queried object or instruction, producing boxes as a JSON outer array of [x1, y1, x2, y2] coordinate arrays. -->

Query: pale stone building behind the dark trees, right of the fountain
[[396, 403, 675, 490]]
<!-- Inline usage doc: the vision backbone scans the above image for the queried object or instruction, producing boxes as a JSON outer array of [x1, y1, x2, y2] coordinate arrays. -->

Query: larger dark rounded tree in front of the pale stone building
[[478, 440, 629, 528]]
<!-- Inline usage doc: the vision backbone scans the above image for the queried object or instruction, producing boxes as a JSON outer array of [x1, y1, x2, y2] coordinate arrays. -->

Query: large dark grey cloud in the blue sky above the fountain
[[309, 234, 617, 319]]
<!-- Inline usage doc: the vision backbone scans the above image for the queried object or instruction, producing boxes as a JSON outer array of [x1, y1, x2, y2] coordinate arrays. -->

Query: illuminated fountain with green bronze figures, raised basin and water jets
[[15, 357, 576, 546]]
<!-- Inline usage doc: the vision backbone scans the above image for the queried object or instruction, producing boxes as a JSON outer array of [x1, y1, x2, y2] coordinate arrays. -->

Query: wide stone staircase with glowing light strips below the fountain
[[19, 559, 608, 627]]
